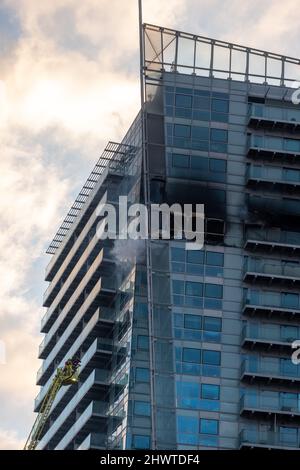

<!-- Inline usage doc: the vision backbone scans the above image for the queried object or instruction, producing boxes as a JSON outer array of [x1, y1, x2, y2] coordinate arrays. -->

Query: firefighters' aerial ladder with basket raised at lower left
[[24, 359, 80, 450]]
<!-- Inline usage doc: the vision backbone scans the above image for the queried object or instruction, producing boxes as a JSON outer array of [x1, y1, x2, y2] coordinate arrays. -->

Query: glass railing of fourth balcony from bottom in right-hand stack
[[242, 322, 300, 347]]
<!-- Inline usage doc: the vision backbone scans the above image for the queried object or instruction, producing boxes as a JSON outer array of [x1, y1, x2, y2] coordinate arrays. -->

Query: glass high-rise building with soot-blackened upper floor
[[35, 25, 300, 450]]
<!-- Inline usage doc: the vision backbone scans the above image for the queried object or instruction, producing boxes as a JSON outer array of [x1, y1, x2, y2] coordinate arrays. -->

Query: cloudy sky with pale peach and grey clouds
[[0, 0, 300, 449]]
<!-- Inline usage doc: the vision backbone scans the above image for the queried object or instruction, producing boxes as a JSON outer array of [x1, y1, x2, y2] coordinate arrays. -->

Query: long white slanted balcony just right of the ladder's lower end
[[38, 369, 107, 449]]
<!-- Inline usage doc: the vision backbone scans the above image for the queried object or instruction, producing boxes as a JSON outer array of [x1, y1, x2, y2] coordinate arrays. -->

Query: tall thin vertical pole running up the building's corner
[[138, 0, 157, 449]]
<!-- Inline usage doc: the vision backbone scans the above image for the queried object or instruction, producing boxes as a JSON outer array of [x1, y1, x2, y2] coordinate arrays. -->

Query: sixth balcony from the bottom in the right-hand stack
[[243, 257, 300, 288]]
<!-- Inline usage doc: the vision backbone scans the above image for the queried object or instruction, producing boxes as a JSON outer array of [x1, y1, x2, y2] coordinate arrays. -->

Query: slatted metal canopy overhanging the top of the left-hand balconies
[[46, 142, 136, 255]]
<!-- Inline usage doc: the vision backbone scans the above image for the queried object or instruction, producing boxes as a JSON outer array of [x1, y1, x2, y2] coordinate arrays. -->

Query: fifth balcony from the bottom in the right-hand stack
[[243, 289, 300, 319]]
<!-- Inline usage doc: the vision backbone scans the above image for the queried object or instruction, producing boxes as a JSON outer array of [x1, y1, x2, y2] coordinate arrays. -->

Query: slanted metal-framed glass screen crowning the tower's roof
[[143, 24, 300, 87]]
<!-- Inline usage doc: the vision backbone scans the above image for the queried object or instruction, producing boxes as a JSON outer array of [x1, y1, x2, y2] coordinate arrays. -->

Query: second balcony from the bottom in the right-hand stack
[[240, 392, 300, 418]]
